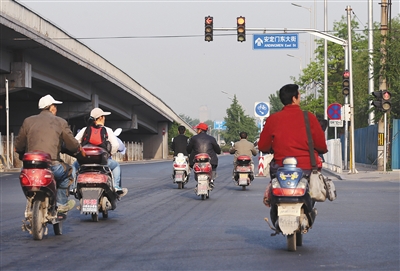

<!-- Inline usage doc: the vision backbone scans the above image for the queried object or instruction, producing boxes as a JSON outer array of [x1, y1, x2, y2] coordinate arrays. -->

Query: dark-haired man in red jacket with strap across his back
[[258, 84, 328, 178]]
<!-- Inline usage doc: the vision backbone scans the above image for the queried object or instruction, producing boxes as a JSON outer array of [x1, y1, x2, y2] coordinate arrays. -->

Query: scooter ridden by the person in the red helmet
[[193, 153, 212, 200]]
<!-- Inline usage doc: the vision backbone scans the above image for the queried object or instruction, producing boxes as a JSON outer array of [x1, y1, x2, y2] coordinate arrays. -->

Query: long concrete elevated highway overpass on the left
[[0, 1, 195, 159]]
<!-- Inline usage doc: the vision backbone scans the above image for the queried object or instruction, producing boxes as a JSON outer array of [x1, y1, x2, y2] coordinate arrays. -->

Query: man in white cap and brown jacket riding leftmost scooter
[[15, 95, 80, 212]]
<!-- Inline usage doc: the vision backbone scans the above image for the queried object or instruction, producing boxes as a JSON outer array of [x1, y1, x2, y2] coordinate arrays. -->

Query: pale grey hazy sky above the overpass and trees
[[17, 0, 399, 121]]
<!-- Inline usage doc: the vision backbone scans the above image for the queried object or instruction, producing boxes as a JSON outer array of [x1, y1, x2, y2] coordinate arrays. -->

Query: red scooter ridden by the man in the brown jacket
[[19, 151, 66, 240]]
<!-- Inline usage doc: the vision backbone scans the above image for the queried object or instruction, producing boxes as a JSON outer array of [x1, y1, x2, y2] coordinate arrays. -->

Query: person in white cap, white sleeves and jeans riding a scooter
[[72, 107, 128, 197]]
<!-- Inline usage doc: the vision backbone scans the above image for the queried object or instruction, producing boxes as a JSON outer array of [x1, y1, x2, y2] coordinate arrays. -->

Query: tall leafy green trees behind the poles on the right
[[269, 16, 400, 137]]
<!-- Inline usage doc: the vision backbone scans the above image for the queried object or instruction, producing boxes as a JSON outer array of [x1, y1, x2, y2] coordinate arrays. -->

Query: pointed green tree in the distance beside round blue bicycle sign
[[221, 95, 258, 144]]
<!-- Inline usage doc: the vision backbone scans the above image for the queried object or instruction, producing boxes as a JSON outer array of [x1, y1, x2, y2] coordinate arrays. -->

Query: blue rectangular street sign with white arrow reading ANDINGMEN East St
[[253, 33, 299, 50]]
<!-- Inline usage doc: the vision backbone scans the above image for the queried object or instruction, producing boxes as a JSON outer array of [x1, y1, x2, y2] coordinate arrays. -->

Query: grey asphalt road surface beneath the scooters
[[0, 155, 400, 271]]
